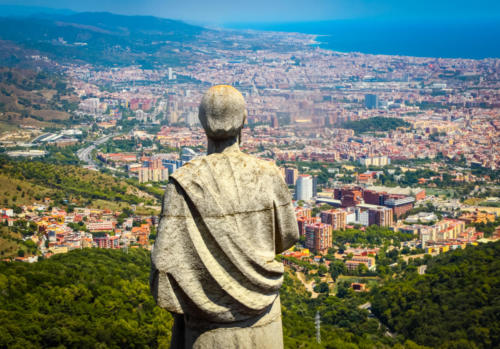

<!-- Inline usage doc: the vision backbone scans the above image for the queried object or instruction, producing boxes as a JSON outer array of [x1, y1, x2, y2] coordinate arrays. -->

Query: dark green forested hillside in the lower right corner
[[372, 242, 500, 348]]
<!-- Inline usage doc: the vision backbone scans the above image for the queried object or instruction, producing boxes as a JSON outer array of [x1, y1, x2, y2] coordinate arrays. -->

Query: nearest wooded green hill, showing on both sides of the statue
[[0, 249, 400, 349]]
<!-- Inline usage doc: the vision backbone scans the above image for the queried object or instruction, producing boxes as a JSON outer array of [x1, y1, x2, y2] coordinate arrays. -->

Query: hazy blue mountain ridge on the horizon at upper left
[[0, 12, 209, 68]]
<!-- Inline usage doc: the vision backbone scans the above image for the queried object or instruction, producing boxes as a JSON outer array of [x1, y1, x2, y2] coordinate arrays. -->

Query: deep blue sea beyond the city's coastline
[[228, 19, 500, 59]]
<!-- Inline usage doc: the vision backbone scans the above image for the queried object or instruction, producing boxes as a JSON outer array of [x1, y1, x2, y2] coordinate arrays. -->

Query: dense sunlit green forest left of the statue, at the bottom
[[0, 249, 172, 348]]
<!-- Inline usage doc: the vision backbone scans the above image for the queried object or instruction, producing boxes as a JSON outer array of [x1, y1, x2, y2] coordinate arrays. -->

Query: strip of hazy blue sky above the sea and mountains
[[0, 0, 500, 24]]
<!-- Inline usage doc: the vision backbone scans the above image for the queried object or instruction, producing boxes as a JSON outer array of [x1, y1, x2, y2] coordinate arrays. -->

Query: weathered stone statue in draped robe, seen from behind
[[151, 85, 299, 349]]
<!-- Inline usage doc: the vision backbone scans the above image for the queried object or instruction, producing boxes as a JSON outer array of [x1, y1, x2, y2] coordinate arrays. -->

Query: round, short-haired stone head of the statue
[[198, 85, 247, 140]]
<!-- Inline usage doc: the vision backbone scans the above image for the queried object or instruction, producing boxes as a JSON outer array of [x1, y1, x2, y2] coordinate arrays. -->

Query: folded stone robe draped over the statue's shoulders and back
[[151, 151, 299, 324]]
